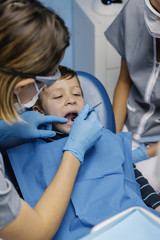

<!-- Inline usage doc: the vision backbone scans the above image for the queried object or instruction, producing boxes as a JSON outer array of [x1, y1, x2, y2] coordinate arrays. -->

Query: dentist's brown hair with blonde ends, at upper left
[[0, 0, 70, 123]]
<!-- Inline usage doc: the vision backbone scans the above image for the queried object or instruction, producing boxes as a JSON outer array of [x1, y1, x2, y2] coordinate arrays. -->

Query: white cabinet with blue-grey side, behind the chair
[[73, 0, 126, 102]]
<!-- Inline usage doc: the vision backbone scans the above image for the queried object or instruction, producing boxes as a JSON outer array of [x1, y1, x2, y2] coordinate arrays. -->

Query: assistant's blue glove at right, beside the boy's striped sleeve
[[132, 144, 150, 163]]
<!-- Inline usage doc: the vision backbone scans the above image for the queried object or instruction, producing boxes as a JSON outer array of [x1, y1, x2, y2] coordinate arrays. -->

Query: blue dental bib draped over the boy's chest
[[8, 129, 160, 240]]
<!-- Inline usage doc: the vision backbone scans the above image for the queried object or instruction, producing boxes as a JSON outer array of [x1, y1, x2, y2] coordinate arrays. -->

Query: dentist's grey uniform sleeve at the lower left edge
[[0, 154, 21, 229]]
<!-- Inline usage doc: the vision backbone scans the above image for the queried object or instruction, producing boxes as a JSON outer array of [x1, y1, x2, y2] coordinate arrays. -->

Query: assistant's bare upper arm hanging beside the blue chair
[[113, 59, 132, 133]]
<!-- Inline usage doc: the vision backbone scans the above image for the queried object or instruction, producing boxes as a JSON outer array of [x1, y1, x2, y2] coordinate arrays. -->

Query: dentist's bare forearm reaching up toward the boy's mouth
[[0, 152, 80, 240]]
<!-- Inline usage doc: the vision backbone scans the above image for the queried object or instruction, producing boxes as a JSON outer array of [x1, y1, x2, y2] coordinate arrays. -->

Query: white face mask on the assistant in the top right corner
[[144, 0, 160, 38]]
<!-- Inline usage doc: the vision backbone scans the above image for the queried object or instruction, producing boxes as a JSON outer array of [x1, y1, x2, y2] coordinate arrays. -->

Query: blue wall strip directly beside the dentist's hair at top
[[40, 0, 74, 68]]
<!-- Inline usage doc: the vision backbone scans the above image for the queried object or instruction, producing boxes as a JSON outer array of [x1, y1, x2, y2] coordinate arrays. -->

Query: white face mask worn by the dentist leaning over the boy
[[15, 82, 44, 108]]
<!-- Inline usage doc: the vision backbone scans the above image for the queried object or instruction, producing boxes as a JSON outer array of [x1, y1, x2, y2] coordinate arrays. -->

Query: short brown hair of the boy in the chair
[[35, 65, 83, 110]]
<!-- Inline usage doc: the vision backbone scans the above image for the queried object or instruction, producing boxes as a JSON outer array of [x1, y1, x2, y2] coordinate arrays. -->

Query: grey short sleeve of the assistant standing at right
[[104, 0, 146, 62]]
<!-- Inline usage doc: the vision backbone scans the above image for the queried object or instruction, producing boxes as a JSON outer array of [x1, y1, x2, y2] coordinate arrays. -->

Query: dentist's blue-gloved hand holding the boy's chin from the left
[[0, 111, 68, 140]]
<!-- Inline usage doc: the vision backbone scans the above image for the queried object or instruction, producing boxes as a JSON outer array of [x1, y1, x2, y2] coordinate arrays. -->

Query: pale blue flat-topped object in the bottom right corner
[[81, 207, 160, 240]]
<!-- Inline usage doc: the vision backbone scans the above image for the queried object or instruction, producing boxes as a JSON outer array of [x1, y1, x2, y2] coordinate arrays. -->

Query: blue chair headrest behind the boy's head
[[76, 71, 116, 133]]
